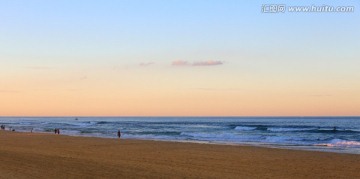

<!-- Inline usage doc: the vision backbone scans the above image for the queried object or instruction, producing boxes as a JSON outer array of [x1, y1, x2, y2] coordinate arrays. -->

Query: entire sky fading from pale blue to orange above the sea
[[0, 0, 360, 116]]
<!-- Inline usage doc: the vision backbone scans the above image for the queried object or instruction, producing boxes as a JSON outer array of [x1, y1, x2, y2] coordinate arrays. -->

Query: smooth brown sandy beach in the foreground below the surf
[[0, 131, 360, 178]]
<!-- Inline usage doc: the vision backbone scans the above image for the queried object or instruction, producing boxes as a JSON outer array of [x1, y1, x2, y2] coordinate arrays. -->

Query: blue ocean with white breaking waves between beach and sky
[[0, 117, 360, 154]]
